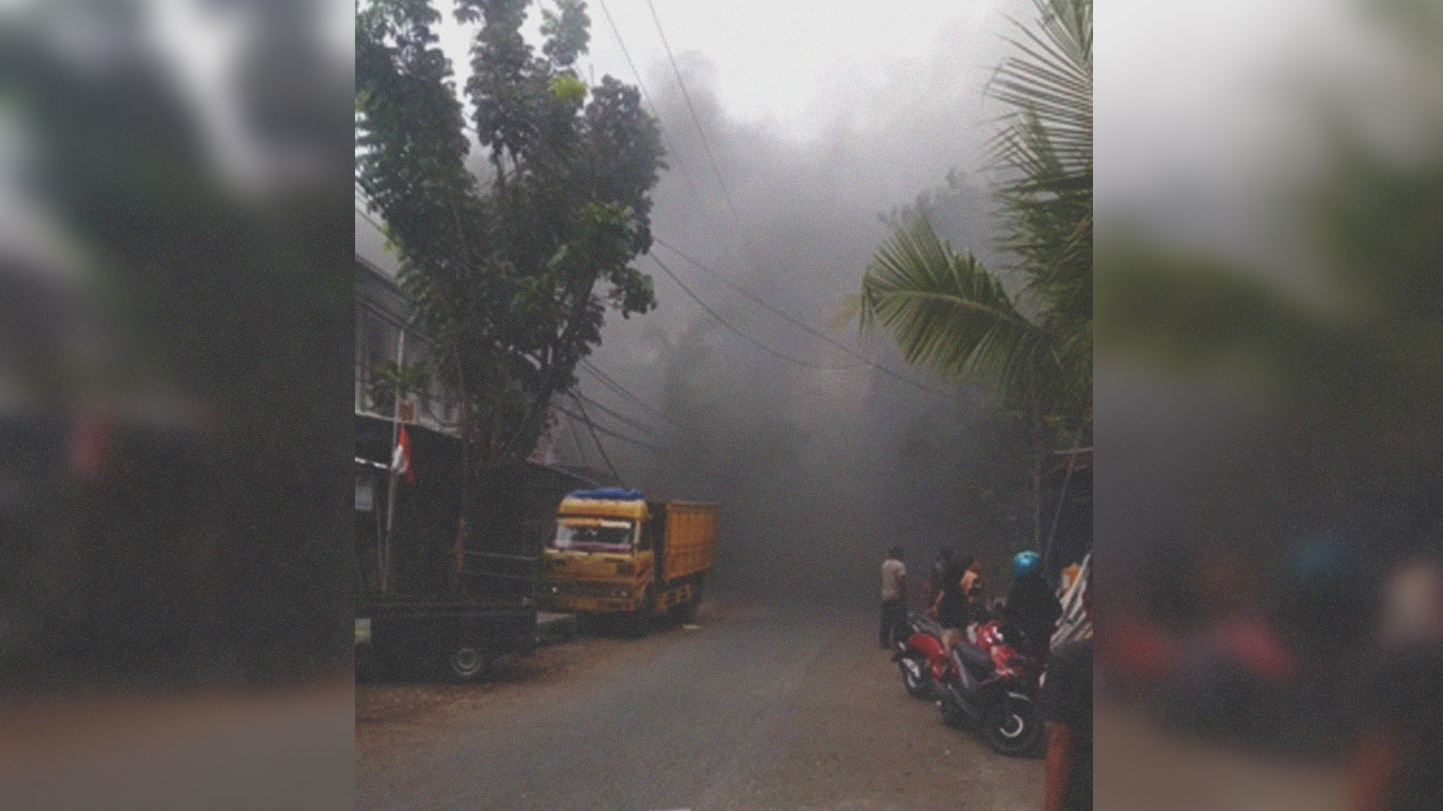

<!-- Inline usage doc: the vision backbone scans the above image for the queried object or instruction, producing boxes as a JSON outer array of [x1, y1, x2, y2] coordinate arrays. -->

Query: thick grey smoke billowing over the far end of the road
[[557, 29, 1032, 603]]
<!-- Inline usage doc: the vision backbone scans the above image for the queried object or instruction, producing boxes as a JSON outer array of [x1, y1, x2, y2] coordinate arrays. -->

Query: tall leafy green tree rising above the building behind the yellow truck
[[356, 0, 664, 543]]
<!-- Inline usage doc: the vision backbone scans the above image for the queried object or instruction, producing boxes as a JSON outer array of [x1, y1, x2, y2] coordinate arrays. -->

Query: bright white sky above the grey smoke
[[356, 0, 1035, 277]]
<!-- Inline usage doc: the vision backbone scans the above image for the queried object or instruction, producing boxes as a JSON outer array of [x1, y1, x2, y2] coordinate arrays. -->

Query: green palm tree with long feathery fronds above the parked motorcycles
[[856, 0, 1092, 444]]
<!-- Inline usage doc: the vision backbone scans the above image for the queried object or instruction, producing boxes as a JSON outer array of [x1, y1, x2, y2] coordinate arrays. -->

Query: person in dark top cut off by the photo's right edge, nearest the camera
[[1042, 589, 1092, 811]]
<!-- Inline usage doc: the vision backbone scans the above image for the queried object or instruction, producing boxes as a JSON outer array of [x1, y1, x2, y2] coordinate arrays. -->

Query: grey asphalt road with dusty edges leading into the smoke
[[356, 606, 1042, 811]]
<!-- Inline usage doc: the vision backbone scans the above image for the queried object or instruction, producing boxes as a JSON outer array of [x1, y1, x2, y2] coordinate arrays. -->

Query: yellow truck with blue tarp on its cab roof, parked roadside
[[538, 489, 717, 634]]
